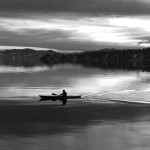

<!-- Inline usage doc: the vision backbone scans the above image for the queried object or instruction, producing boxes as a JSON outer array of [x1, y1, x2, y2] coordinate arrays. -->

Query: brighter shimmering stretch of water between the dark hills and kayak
[[0, 65, 150, 101]]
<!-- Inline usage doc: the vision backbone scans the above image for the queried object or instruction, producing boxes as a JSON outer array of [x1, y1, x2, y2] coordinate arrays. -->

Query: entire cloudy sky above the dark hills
[[0, 0, 150, 51]]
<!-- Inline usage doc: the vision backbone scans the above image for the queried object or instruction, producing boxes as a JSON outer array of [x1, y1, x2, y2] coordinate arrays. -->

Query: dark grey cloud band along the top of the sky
[[0, 0, 150, 15]]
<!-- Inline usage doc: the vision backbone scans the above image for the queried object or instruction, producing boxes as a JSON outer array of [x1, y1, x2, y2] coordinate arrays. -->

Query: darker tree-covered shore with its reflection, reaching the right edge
[[41, 47, 150, 71]]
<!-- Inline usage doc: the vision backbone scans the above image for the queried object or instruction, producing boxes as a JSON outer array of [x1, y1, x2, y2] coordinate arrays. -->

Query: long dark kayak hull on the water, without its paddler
[[39, 95, 81, 101]]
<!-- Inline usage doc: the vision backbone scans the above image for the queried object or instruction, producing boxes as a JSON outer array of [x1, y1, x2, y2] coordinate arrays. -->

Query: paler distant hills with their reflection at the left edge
[[0, 48, 58, 67]]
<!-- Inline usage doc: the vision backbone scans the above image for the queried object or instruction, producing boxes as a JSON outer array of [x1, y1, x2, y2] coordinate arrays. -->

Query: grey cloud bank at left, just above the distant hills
[[0, 29, 100, 50]]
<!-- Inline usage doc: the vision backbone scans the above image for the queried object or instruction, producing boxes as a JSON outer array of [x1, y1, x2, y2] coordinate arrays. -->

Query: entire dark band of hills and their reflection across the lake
[[0, 48, 150, 70]]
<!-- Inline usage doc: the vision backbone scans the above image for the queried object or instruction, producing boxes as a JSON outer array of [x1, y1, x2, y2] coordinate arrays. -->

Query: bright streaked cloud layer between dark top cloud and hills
[[0, 17, 150, 50]]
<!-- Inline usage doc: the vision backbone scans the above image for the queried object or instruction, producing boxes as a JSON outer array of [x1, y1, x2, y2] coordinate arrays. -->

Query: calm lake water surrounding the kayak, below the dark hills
[[0, 64, 150, 150]]
